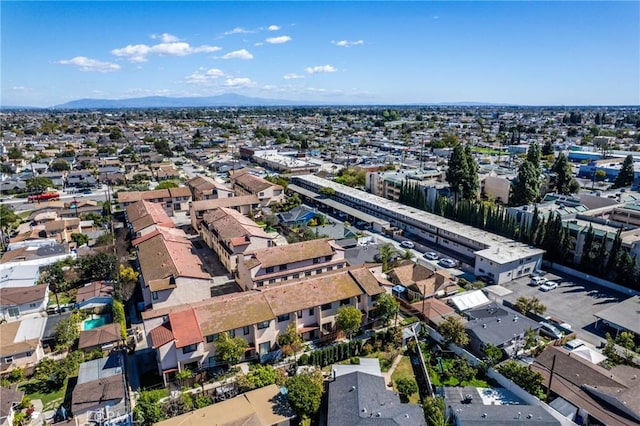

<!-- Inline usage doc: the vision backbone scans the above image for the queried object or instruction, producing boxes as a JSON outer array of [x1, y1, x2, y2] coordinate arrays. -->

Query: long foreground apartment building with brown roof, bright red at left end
[[142, 267, 385, 381]]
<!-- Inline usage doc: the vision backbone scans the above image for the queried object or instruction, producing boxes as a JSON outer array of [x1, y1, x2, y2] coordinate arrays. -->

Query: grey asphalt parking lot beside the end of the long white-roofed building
[[503, 273, 629, 345]]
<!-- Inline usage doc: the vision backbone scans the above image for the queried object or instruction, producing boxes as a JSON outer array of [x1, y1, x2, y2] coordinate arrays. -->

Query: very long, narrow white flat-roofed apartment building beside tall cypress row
[[289, 175, 544, 284]]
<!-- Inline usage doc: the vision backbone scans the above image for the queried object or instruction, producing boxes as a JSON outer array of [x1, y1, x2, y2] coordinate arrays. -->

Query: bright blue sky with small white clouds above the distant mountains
[[0, 1, 640, 106]]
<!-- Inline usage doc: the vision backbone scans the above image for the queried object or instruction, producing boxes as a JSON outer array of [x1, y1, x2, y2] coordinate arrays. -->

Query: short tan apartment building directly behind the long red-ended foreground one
[[236, 238, 347, 290]]
